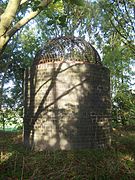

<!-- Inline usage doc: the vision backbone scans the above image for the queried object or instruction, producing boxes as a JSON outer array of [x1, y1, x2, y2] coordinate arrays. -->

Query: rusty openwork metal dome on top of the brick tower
[[35, 36, 101, 64]]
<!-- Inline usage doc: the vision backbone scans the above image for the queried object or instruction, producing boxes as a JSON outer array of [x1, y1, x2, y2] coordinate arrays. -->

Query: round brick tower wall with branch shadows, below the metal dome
[[24, 35, 111, 150]]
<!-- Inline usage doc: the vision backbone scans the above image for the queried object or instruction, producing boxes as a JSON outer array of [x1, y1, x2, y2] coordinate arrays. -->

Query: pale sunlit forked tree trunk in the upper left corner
[[0, 0, 52, 57]]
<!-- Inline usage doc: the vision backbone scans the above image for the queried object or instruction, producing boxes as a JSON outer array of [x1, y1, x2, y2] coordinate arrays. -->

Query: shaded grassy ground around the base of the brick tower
[[0, 127, 135, 180]]
